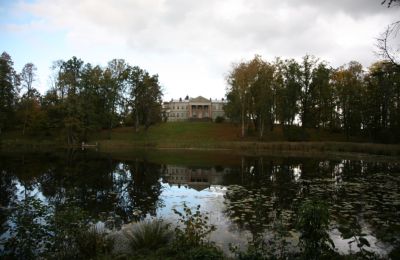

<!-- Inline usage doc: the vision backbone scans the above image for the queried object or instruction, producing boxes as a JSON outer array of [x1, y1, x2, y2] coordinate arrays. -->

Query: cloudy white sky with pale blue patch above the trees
[[0, 0, 400, 100]]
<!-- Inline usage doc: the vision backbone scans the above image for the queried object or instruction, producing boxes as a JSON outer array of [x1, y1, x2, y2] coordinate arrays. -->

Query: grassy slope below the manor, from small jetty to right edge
[[93, 122, 400, 156]]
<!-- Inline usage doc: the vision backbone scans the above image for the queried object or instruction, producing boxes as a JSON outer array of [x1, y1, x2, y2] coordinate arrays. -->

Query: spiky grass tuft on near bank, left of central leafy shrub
[[125, 219, 173, 250]]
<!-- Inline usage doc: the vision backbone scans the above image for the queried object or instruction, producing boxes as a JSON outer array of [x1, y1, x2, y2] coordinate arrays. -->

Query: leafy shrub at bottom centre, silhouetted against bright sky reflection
[[173, 202, 216, 249]]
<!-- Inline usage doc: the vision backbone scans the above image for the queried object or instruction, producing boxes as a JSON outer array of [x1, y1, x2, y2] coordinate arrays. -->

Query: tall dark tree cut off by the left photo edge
[[0, 52, 19, 135]]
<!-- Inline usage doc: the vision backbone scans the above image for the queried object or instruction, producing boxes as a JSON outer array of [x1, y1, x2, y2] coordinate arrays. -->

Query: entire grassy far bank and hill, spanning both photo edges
[[0, 122, 400, 156]]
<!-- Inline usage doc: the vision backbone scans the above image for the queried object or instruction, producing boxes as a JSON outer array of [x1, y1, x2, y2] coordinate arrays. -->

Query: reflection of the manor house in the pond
[[162, 165, 230, 191]]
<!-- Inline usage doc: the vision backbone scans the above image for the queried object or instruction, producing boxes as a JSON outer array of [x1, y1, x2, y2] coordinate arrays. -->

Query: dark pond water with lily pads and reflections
[[0, 151, 400, 255]]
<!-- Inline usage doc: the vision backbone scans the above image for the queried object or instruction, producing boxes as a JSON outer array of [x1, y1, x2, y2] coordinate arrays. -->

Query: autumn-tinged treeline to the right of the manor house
[[225, 55, 400, 142]]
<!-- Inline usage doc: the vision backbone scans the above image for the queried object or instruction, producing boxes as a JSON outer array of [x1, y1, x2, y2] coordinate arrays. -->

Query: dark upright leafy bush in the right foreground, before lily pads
[[297, 201, 335, 259]]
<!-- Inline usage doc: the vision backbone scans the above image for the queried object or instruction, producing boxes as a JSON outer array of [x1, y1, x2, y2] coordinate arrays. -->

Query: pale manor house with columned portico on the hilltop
[[163, 96, 226, 122]]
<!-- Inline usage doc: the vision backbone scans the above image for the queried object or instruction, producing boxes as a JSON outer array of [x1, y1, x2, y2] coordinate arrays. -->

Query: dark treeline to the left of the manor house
[[0, 52, 162, 144]]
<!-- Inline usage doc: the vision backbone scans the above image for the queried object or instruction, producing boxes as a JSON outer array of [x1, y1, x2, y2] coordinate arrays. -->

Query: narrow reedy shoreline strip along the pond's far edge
[[0, 140, 400, 161]]
